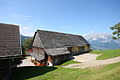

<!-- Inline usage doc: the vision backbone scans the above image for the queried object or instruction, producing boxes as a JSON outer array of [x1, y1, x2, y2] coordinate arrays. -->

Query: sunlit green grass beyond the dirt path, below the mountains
[[92, 49, 120, 60]]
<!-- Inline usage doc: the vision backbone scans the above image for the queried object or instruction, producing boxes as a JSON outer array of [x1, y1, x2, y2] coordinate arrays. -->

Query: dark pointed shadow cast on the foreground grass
[[12, 66, 57, 80]]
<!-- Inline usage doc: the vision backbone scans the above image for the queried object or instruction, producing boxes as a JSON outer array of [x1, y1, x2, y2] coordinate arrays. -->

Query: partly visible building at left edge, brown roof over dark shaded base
[[0, 23, 21, 80]]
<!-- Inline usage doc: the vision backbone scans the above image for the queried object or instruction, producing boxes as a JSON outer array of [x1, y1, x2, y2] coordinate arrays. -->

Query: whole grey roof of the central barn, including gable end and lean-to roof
[[32, 30, 90, 55]]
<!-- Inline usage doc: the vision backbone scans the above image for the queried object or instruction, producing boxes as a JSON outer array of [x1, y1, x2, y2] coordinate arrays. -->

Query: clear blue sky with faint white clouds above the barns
[[0, 0, 120, 36]]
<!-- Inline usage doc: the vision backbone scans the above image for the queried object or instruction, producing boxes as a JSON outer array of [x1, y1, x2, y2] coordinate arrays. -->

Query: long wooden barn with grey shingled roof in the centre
[[30, 30, 90, 66]]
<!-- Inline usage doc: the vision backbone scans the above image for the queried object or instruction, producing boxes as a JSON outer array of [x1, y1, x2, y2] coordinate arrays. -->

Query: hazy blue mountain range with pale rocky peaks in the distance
[[84, 33, 120, 50]]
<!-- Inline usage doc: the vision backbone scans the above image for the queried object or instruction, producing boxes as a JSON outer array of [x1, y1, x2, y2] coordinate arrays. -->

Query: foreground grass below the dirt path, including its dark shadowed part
[[12, 63, 120, 80]]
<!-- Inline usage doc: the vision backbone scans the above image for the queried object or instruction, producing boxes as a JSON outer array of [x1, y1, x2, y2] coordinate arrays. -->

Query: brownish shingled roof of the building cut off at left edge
[[0, 23, 21, 57]]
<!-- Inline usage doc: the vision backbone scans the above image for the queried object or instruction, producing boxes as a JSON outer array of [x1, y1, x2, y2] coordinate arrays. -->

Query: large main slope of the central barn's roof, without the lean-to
[[37, 30, 89, 49]]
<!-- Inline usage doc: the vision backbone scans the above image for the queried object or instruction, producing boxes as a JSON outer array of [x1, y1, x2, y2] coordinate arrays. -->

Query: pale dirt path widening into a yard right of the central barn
[[64, 53, 120, 69]]
